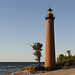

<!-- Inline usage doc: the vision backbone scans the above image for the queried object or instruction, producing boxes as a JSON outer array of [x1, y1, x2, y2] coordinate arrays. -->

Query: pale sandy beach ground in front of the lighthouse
[[6, 68, 75, 75]]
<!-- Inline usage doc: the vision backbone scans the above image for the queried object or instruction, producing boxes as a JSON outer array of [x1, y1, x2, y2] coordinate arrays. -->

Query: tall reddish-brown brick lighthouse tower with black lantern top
[[45, 8, 55, 68]]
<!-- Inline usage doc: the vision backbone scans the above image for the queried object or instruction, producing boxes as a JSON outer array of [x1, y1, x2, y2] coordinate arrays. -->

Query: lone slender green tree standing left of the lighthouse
[[31, 42, 43, 66]]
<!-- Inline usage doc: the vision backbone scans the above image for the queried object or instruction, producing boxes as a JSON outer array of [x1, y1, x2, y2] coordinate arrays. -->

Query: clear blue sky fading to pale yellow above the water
[[0, 0, 75, 62]]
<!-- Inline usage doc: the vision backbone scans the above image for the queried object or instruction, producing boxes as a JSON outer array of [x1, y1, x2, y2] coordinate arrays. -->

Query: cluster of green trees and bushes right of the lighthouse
[[56, 50, 75, 66]]
